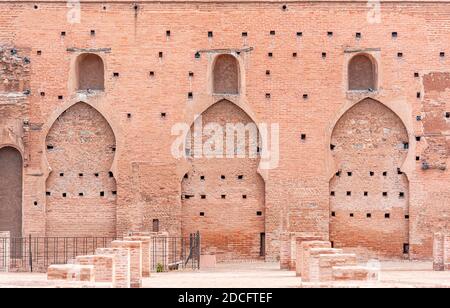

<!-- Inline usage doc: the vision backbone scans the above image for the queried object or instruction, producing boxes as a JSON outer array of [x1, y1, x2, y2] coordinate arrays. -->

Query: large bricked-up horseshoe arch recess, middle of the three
[[181, 100, 265, 261]]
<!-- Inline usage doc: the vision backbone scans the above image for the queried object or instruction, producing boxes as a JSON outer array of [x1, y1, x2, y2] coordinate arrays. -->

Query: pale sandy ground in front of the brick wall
[[0, 262, 450, 288]]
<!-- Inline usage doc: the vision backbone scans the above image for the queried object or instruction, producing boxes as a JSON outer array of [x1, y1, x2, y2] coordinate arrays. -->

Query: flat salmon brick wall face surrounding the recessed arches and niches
[[0, 0, 450, 259]]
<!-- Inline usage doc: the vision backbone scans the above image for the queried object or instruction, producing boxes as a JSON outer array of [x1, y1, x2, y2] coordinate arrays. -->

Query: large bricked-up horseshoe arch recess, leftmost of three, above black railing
[[46, 102, 117, 236]]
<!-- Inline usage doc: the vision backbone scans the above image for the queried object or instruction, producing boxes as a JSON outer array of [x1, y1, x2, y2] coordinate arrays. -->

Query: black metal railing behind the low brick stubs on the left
[[0, 232, 200, 272]]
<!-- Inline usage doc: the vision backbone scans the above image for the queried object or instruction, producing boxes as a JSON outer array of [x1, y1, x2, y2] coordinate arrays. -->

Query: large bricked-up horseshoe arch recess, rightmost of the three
[[330, 98, 409, 258]]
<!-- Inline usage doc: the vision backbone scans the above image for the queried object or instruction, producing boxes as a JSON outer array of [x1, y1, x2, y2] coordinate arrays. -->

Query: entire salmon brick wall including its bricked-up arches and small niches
[[0, 0, 450, 262]]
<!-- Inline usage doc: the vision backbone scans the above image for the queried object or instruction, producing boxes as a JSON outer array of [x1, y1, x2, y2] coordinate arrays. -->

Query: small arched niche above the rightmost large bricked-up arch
[[348, 54, 378, 91]]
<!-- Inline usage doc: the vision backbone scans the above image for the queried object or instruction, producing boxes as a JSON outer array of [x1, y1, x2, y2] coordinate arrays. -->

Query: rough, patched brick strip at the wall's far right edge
[[410, 70, 450, 256]]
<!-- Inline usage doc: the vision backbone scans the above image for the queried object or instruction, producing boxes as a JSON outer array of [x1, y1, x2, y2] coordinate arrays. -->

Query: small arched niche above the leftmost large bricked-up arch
[[76, 53, 105, 91]]
